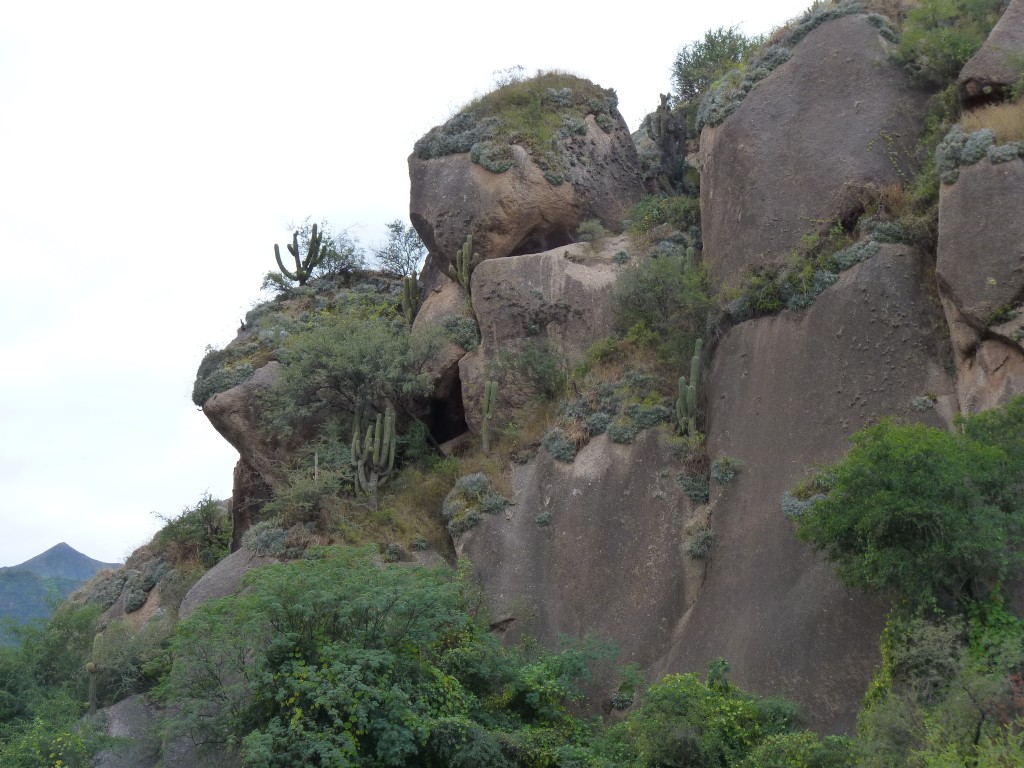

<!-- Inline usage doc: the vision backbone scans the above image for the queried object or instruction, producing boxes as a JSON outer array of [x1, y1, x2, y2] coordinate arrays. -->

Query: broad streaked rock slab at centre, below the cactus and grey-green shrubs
[[458, 429, 705, 667]]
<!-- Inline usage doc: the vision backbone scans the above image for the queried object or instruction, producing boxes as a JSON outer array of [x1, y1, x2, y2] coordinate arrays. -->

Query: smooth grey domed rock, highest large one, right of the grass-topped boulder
[[699, 15, 926, 282]]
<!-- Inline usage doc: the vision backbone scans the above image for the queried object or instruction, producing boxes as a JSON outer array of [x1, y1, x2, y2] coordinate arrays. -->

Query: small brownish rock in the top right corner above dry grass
[[957, 0, 1024, 106]]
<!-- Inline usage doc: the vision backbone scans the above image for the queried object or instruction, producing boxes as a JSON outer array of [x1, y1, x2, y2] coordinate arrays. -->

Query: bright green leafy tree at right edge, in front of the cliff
[[797, 397, 1024, 606]]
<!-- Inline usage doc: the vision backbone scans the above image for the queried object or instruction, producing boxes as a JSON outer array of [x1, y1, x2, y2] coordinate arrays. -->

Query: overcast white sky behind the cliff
[[0, 0, 809, 565]]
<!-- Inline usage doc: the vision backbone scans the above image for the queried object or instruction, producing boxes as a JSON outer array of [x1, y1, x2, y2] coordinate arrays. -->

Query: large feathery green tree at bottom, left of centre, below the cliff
[[165, 549, 606, 767]]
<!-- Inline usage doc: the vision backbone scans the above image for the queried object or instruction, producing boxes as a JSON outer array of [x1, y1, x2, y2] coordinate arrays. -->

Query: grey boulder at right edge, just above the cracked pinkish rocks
[[935, 160, 1024, 330]]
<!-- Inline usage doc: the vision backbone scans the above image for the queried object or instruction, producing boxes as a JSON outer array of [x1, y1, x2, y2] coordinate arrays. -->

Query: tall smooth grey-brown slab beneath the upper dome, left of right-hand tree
[[657, 246, 955, 731]]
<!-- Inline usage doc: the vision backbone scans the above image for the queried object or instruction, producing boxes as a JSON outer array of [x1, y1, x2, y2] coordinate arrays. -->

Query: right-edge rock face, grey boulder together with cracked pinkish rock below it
[[936, 152, 1024, 413]]
